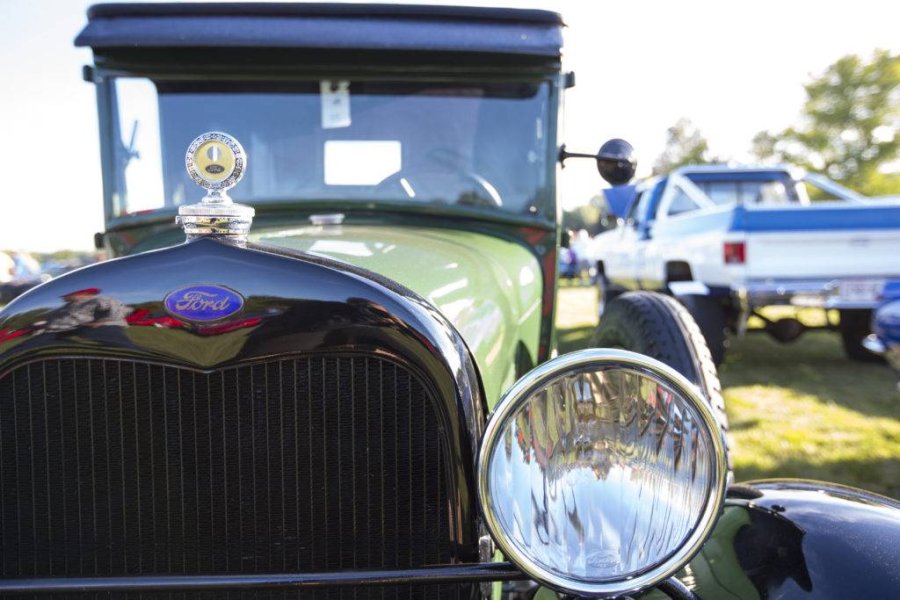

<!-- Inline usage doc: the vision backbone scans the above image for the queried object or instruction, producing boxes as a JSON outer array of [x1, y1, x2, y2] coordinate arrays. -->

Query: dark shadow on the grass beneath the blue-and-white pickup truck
[[719, 332, 900, 419]]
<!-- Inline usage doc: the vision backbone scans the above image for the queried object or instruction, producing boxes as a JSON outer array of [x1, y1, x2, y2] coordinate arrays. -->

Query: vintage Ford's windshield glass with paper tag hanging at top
[[111, 78, 550, 216]]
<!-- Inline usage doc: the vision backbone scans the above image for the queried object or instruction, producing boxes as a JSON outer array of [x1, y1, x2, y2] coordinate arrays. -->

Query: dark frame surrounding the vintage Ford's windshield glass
[[94, 67, 562, 231]]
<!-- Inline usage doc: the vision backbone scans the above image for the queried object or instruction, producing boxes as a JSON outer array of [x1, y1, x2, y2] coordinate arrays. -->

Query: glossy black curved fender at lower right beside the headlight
[[679, 480, 900, 599]]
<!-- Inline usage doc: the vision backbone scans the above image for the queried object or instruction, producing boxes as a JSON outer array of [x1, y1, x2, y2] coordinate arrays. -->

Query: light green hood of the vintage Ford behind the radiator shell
[[251, 225, 543, 407]]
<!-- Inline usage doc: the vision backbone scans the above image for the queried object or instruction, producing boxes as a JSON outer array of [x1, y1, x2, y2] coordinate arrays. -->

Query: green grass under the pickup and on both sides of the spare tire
[[557, 287, 900, 498]]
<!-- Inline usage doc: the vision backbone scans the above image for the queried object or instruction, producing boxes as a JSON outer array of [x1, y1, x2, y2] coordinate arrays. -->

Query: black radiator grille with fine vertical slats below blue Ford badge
[[0, 355, 464, 600]]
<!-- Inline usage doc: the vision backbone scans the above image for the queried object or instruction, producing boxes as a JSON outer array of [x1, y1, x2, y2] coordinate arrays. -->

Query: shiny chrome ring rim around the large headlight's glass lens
[[478, 349, 727, 596]]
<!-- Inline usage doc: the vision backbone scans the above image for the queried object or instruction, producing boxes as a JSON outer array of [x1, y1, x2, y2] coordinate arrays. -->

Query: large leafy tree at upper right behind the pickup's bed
[[753, 50, 900, 195]]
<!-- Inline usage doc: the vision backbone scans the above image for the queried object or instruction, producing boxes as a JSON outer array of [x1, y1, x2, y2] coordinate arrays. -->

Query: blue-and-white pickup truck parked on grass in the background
[[594, 166, 900, 364]]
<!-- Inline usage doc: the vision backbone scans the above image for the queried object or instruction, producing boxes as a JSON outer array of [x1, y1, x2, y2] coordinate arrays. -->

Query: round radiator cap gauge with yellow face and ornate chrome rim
[[184, 131, 247, 191]]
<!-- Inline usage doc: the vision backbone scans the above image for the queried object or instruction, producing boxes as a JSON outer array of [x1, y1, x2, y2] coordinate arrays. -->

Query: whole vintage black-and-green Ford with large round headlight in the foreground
[[0, 4, 900, 599]]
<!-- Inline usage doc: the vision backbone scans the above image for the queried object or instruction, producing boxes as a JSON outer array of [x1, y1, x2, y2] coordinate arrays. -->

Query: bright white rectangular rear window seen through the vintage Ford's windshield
[[325, 140, 402, 185]]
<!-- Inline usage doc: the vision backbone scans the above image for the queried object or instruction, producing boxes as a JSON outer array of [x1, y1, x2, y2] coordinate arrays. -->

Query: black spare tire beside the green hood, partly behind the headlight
[[594, 292, 732, 474]]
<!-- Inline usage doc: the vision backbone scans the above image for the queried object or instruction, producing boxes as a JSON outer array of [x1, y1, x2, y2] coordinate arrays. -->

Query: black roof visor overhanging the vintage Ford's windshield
[[75, 3, 563, 58]]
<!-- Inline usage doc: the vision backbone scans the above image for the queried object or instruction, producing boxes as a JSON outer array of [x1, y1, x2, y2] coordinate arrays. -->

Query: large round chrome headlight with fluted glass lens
[[478, 350, 726, 595]]
